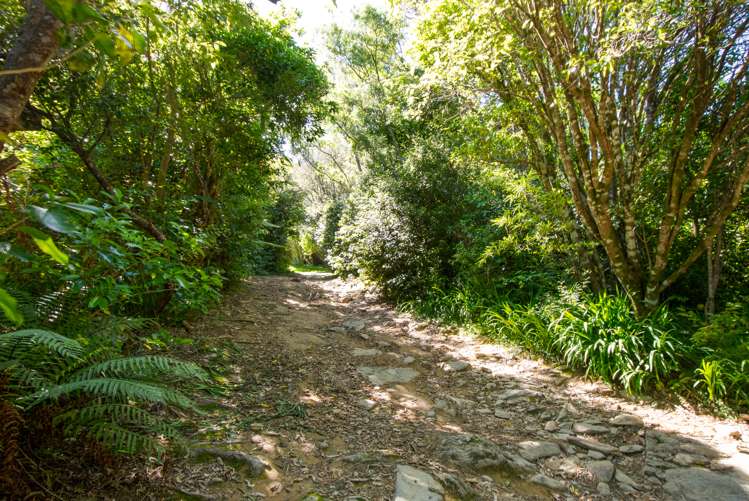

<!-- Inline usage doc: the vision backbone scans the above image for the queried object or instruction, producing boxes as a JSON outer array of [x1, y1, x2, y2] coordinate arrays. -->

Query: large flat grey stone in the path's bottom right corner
[[663, 468, 749, 501]]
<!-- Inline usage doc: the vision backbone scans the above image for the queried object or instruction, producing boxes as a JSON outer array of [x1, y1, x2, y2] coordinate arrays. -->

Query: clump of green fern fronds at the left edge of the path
[[0, 329, 208, 454]]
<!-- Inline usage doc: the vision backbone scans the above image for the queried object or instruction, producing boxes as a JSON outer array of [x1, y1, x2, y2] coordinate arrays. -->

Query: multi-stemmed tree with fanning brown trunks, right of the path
[[421, 0, 749, 314]]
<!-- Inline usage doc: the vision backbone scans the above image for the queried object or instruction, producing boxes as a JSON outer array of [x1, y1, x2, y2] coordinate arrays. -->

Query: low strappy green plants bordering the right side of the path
[[400, 287, 749, 415]]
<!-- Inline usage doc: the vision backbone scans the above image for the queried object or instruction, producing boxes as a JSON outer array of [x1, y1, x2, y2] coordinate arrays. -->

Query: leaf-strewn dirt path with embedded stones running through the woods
[[171, 274, 749, 501]]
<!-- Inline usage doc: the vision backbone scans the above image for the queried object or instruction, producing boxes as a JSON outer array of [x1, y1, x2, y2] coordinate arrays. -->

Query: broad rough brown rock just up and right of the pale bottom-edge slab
[[437, 433, 507, 470]]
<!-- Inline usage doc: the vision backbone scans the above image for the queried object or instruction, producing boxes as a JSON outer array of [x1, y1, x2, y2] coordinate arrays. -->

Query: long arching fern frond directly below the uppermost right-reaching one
[[28, 378, 194, 409]]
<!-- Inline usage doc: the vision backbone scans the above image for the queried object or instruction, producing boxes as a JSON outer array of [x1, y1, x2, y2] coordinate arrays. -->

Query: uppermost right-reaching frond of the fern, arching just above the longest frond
[[70, 356, 209, 383]]
